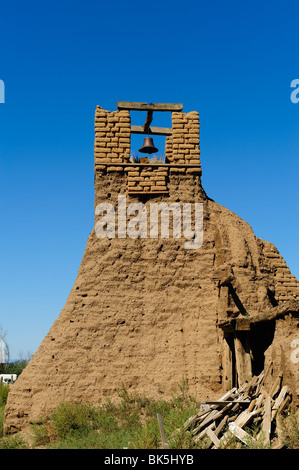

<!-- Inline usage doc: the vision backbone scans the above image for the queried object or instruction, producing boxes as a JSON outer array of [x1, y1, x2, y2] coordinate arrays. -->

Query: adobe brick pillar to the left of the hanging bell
[[94, 106, 131, 165]]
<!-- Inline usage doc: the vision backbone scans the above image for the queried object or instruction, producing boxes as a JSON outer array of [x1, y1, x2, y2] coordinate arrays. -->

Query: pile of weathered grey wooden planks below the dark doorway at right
[[184, 365, 291, 449]]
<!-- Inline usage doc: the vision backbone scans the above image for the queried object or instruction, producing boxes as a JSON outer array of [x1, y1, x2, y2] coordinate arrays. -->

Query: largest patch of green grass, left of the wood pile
[[28, 376, 203, 449]]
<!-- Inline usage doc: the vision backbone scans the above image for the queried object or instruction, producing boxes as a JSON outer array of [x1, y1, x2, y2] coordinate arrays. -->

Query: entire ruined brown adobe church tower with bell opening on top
[[5, 102, 299, 431]]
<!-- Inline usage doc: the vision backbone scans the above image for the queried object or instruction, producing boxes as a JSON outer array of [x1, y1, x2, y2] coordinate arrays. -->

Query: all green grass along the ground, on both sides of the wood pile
[[0, 381, 299, 449]]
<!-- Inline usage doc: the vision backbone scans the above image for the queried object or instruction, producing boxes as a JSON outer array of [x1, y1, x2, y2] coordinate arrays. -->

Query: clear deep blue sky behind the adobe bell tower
[[0, 0, 299, 358]]
